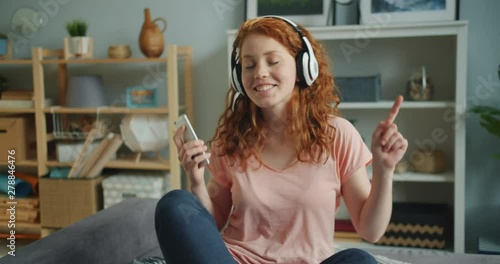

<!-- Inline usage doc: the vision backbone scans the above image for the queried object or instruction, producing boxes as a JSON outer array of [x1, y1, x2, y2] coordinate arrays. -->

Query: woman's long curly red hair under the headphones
[[211, 17, 340, 168]]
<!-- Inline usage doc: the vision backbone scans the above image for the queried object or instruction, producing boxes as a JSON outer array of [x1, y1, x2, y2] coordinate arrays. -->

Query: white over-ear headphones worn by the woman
[[231, 16, 319, 95]]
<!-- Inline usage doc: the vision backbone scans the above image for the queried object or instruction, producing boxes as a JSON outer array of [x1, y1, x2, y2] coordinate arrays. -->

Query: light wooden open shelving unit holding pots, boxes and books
[[0, 45, 194, 239]]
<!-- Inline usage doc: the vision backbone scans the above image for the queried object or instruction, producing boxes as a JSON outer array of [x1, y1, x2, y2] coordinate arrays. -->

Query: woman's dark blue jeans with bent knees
[[155, 190, 377, 264]]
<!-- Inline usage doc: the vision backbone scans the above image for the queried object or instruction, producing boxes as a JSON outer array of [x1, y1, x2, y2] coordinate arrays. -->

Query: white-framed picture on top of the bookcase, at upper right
[[359, 0, 457, 25]]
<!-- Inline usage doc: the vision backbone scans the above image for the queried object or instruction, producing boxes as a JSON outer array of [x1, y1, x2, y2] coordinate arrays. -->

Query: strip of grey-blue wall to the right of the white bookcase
[[460, 0, 500, 252]]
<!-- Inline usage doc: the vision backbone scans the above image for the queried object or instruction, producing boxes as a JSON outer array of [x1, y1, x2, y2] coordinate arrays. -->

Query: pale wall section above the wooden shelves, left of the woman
[[0, 0, 244, 139]]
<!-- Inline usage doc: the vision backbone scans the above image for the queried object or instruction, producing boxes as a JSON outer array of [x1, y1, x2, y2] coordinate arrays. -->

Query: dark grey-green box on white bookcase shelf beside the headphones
[[334, 75, 382, 102]]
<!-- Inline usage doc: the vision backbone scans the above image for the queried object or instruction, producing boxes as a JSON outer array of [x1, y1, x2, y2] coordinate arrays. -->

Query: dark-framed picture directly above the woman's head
[[245, 0, 331, 26]]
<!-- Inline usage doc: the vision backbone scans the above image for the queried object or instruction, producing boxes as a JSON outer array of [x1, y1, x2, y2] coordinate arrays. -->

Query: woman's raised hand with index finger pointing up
[[371, 95, 408, 172]]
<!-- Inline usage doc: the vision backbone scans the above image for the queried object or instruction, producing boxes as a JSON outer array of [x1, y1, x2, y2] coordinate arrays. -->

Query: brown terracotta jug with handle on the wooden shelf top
[[139, 8, 167, 58]]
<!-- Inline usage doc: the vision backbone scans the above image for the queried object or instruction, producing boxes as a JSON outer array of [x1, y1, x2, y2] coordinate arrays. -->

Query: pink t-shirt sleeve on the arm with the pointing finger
[[333, 117, 372, 184]]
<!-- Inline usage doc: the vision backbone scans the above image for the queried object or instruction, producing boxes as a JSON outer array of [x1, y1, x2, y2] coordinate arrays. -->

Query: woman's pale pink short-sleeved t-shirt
[[210, 117, 371, 264]]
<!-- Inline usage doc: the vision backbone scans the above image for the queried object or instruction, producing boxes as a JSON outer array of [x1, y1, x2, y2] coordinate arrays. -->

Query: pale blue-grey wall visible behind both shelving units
[[0, 0, 500, 252]]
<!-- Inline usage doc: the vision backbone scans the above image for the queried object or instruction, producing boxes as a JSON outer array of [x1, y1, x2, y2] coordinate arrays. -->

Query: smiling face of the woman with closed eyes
[[241, 33, 297, 110]]
